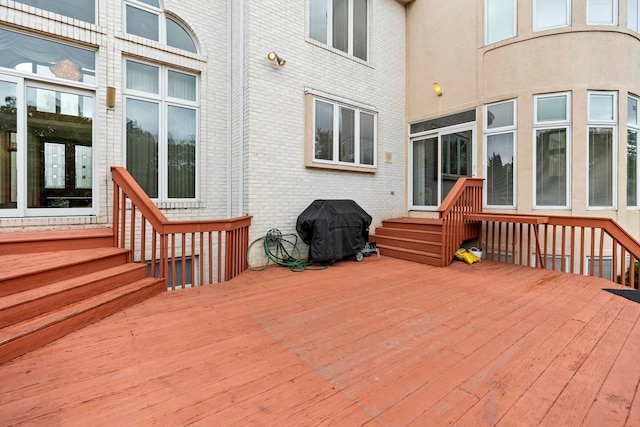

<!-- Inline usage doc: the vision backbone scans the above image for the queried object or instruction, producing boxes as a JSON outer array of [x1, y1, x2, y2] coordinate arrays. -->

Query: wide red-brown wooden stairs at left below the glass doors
[[0, 228, 165, 364]]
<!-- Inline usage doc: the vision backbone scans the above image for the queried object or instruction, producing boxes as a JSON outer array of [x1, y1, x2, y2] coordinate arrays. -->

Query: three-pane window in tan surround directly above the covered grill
[[307, 93, 377, 169]]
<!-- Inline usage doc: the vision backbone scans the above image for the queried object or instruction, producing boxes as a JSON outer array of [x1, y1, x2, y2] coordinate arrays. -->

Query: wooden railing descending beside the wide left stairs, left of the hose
[[111, 166, 251, 289]]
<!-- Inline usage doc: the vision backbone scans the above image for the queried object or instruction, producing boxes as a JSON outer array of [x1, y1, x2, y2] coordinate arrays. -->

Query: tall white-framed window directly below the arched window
[[125, 60, 198, 200]]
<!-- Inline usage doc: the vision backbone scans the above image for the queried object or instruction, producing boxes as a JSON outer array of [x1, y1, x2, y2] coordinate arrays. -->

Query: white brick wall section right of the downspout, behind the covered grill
[[245, 0, 406, 246]]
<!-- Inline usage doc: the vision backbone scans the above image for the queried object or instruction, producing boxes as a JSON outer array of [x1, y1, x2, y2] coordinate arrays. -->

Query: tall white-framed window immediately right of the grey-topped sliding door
[[484, 99, 517, 207]]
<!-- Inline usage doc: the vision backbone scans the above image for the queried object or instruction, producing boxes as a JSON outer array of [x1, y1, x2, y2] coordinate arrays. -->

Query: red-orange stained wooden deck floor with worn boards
[[0, 256, 640, 427]]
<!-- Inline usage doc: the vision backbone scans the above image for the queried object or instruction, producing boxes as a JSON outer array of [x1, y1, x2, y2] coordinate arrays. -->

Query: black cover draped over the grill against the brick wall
[[296, 200, 372, 262]]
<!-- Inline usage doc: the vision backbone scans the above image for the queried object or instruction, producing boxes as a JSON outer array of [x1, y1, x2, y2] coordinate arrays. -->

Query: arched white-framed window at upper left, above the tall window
[[125, 0, 198, 53]]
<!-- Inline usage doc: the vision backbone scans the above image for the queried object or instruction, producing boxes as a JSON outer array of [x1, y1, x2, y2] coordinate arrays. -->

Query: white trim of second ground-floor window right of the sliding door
[[531, 92, 572, 210]]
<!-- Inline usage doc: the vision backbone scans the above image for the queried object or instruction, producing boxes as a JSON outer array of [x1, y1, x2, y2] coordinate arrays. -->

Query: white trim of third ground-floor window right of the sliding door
[[585, 90, 618, 211]]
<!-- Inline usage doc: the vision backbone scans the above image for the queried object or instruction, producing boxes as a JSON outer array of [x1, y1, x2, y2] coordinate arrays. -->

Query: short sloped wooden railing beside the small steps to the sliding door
[[438, 178, 483, 267]]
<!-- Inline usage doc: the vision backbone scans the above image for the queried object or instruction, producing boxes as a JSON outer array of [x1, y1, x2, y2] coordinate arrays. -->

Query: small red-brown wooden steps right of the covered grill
[[369, 218, 442, 267]]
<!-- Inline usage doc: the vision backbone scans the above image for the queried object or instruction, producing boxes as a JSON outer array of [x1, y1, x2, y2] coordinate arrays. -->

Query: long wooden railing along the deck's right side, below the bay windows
[[466, 213, 640, 289]]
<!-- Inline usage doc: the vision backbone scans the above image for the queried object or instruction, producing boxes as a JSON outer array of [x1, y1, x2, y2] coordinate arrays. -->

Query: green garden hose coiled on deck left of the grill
[[247, 228, 327, 271]]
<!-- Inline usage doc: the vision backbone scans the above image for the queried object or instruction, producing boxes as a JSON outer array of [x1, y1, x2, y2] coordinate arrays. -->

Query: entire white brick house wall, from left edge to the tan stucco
[[0, 0, 406, 260]]
